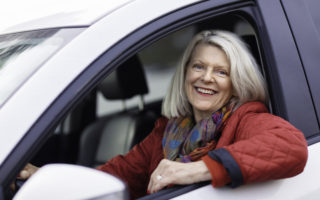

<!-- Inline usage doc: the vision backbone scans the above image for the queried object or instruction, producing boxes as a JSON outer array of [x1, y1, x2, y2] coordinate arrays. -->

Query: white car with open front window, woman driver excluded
[[0, 0, 320, 200]]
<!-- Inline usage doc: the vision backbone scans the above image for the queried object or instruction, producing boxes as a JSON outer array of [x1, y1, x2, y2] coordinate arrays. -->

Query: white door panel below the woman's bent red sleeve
[[174, 143, 320, 200]]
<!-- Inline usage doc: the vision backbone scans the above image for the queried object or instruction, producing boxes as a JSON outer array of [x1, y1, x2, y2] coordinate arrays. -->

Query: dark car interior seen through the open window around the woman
[[26, 14, 264, 198]]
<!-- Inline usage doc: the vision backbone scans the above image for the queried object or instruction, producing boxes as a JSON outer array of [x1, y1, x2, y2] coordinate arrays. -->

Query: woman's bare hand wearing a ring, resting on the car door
[[148, 159, 211, 193]]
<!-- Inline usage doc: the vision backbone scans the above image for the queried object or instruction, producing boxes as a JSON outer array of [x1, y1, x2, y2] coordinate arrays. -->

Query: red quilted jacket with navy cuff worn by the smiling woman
[[98, 102, 307, 198]]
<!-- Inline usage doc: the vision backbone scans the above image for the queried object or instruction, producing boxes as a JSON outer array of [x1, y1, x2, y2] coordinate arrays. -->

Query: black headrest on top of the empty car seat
[[98, 56, 148, 99]]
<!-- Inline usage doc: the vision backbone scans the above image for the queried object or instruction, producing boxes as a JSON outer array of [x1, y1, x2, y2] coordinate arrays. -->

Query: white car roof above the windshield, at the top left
[[0, 0, 134, 35]]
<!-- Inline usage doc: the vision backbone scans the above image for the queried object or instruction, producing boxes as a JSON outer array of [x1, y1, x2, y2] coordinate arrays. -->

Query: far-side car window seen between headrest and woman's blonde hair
[[97, 26, 196, 116]]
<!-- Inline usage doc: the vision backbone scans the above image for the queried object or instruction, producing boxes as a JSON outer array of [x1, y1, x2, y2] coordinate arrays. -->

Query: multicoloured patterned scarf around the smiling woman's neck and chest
[[162, 104, 233, 162]]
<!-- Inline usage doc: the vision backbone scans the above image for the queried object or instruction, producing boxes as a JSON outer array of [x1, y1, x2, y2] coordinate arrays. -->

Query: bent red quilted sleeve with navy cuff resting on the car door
[[203, 113, 308, 187]]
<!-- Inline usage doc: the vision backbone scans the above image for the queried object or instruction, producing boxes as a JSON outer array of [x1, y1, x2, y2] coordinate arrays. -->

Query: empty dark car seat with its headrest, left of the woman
[[78, 56, 157, 167]]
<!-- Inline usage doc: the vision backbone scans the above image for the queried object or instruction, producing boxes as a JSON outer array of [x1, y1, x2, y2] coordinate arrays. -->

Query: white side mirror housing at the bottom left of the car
[[14, 164, 129, 200]]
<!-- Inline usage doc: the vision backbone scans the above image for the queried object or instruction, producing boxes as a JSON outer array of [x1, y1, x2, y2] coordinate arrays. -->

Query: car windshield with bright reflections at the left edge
[[0, 28, 83, 107]]
